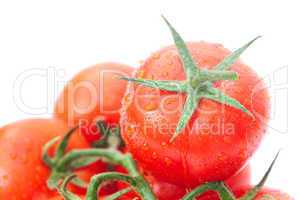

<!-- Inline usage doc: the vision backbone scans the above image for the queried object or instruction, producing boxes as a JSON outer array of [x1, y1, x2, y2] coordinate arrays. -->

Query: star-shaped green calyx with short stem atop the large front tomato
[[121, 17, 260, 142]]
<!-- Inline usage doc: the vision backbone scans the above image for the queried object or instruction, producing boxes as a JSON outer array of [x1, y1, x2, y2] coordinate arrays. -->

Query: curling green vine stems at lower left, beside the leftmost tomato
[[43, 127, 155, 200]]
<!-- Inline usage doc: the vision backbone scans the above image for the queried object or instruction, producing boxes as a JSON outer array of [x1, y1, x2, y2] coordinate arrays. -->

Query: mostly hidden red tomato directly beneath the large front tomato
[[117, 165, 251, 200]]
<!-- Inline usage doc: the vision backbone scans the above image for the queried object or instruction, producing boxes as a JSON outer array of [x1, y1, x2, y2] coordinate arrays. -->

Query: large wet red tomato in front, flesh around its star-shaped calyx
[[120, 42, 269, 187]]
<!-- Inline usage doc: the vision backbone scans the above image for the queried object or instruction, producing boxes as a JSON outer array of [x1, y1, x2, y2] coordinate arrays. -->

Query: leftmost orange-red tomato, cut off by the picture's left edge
[[0, 119, 94, 200]]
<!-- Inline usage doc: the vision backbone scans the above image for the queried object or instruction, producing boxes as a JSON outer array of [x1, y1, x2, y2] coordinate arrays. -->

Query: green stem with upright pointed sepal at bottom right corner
[[182, 152, 279, 200]]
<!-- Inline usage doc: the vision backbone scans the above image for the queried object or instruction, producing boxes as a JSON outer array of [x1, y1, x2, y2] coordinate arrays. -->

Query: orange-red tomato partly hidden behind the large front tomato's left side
[[54, 63, 133, 142]]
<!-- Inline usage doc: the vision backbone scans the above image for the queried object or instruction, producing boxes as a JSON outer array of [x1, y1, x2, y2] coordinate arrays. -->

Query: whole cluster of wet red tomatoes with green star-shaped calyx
[[0, 18, 292, 200]]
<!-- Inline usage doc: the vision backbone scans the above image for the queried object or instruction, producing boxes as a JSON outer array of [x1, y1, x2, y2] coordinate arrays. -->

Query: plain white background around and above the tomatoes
[[0, 0, 300, 198]]
